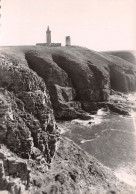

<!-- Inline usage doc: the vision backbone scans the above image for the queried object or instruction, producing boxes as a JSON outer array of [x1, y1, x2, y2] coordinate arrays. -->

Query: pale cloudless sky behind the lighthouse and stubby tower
[[0, 0, 136, 51]]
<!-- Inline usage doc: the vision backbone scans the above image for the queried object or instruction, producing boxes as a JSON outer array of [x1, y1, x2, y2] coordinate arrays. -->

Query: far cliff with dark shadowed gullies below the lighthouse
[[25, 47, 136, 116]]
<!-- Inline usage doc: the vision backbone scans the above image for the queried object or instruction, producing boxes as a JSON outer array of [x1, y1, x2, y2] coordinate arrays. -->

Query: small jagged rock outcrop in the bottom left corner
[[0, 145, 31, 194]]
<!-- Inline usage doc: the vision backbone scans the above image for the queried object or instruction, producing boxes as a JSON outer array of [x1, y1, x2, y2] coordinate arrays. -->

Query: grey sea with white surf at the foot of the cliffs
[[58, 93, 136, 188]]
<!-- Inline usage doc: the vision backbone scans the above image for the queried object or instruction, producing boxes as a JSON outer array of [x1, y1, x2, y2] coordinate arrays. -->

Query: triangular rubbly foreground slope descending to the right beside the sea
[[27, 138, 133, 194]]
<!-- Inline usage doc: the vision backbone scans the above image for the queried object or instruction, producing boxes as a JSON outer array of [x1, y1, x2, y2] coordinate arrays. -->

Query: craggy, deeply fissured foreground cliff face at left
[[0, 52, 57, 162]]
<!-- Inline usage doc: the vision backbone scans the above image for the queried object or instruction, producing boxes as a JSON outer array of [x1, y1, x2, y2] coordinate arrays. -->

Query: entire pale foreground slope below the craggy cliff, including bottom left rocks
[[0, 138, 134, 194]]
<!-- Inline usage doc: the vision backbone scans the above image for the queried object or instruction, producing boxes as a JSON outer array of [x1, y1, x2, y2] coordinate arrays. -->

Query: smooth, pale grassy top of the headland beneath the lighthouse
[[0, 46, 134, 68]]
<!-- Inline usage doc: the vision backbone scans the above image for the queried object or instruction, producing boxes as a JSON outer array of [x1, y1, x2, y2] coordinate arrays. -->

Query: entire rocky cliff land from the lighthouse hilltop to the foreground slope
[[0, 47, 136, 194]]
